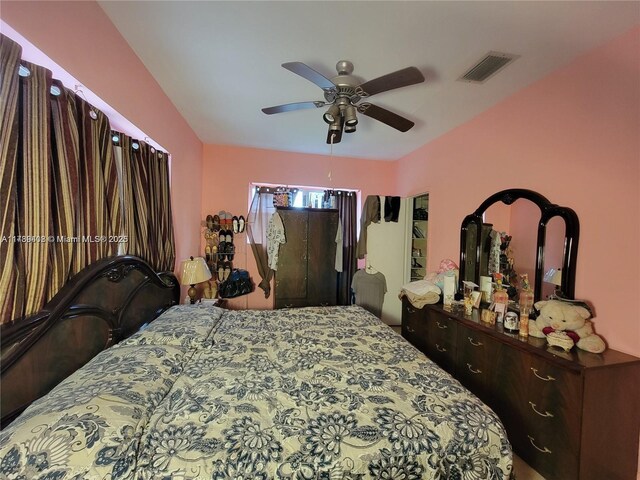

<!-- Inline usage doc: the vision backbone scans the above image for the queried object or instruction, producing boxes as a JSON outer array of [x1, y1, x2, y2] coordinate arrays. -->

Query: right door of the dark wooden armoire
[[307, 210, 338, 305]]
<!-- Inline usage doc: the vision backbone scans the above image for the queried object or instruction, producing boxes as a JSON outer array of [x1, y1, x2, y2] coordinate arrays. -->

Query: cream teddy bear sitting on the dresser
[[529, 300, 607, 353]]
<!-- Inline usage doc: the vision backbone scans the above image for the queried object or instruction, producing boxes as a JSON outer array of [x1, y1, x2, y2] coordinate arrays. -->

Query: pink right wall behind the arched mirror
[[398, 27, 640, 355]]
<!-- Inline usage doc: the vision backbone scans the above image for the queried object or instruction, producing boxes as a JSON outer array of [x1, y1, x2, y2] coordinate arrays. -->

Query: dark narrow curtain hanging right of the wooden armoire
[[325, 190, 358, 305]]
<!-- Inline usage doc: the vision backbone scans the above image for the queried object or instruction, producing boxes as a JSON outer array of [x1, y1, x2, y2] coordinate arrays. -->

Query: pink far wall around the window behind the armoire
[[202, 145, 397, 308]]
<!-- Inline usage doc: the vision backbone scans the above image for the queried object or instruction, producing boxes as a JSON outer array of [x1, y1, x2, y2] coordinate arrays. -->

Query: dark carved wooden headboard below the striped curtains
[[0, 255, 180, 428]]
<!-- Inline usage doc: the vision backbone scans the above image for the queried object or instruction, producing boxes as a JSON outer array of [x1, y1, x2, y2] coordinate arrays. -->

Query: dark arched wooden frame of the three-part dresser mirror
[[458, 188, 580, 301]]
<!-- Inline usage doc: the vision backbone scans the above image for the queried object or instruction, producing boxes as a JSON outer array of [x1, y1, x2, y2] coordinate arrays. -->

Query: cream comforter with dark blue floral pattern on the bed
[[0, 306, 512, 480]]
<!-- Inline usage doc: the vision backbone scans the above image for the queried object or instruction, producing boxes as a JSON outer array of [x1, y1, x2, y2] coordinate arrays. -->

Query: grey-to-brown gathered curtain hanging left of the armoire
[[247, 187, 279, 298]]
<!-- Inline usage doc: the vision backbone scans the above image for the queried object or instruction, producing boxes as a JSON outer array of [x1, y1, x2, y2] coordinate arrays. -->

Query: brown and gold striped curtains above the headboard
[[0, 35, 175, 323]]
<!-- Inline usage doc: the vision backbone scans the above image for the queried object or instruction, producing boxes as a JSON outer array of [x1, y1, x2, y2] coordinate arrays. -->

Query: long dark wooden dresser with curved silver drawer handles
[[402, 298, 640, 480]]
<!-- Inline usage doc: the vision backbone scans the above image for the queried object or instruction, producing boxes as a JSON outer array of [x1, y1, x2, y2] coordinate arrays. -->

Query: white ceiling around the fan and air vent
[[100, 1, 640, 160]]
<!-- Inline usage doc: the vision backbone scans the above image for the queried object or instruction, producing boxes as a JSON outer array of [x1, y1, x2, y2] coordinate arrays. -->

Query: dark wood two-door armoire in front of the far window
[[275, 207, 338, 308]]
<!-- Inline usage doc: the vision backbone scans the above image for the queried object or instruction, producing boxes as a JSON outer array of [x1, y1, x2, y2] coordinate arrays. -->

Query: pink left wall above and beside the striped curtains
[[0, 1, 202, 266]]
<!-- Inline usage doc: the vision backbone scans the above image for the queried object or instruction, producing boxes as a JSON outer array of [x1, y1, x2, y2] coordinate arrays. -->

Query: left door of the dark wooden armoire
[[275, 209, 309, 308]]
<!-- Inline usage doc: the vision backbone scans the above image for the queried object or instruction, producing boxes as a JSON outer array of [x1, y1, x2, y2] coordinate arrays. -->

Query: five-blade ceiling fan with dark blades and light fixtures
[[262, 60, 424, 144]]
